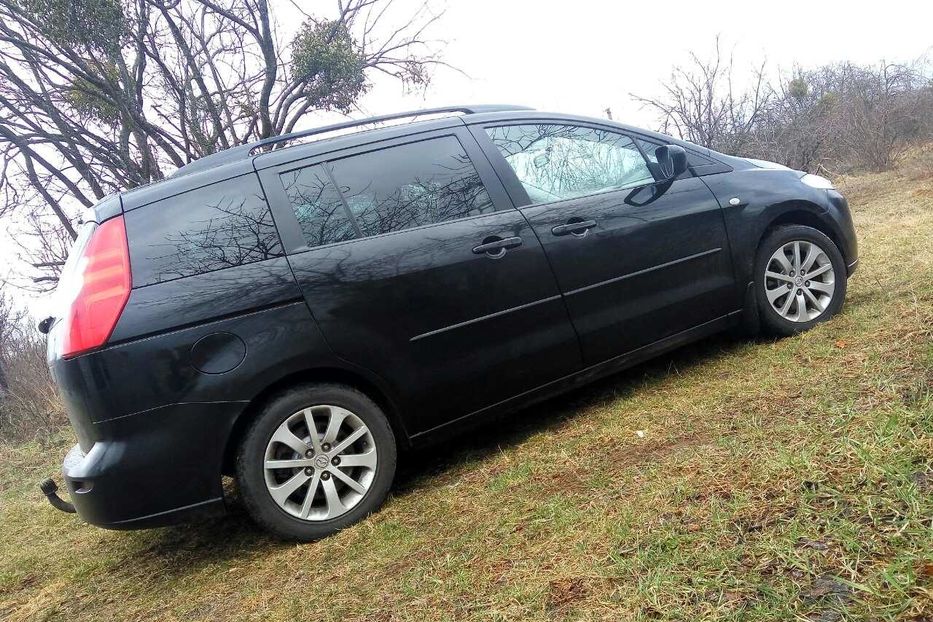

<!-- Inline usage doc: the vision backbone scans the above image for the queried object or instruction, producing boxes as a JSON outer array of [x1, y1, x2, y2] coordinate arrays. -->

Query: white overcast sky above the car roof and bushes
[[7, 0, 933, 315]]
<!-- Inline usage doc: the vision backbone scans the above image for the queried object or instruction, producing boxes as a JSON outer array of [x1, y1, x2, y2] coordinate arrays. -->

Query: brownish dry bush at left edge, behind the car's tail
[[0, 292, 67, 442]]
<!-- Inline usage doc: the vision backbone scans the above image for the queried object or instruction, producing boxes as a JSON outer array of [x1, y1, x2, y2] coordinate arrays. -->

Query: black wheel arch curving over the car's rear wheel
[[222, 367, 411, 475]]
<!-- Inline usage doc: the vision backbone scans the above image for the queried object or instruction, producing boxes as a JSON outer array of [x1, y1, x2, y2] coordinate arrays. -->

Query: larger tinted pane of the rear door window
[[328, 136, 493, 236]]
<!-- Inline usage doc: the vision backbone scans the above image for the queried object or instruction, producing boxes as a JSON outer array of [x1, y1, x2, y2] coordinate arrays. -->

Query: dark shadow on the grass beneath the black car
[[119, 335, 748, 582]]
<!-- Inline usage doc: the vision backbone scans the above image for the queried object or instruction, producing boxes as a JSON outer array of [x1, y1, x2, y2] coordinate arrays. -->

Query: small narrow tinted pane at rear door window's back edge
[[280, 166, 356, 246]]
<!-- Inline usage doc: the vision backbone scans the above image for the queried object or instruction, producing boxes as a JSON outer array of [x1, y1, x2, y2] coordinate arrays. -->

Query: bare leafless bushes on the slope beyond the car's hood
[[637, 39, 933, 174]]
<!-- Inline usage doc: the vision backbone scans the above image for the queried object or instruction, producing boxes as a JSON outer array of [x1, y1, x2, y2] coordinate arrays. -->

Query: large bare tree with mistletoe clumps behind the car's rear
[[0, 0, 452, 286]]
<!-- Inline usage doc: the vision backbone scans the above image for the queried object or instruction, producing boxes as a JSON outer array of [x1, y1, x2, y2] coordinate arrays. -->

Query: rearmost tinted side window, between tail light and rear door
[[125, 175, 282, 286]]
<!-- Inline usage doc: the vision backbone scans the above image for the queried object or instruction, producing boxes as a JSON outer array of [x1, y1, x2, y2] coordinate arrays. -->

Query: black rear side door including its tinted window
[[256, 127, 582, 435]]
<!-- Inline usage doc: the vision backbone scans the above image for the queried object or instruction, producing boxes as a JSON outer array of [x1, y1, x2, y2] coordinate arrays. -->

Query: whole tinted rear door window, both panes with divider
[[280, 136, 495, 246]]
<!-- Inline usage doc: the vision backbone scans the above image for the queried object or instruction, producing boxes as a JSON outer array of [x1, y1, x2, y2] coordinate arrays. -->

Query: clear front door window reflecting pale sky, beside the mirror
[[486, 123, 654, 203]]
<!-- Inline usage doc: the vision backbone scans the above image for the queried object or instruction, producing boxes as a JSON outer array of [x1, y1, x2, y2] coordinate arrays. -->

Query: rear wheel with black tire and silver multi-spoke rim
[[236, 384, 397, 541]]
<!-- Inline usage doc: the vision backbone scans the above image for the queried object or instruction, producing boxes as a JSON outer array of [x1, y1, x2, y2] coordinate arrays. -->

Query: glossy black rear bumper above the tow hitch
[[55, 403, 242, 529]]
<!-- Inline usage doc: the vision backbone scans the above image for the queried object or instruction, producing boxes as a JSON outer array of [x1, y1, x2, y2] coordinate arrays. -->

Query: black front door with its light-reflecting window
[[472, 121, 736, 365]]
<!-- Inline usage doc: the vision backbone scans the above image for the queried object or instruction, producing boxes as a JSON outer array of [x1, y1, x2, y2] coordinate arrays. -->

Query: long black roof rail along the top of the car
[[171, 104, 534, 177]]
